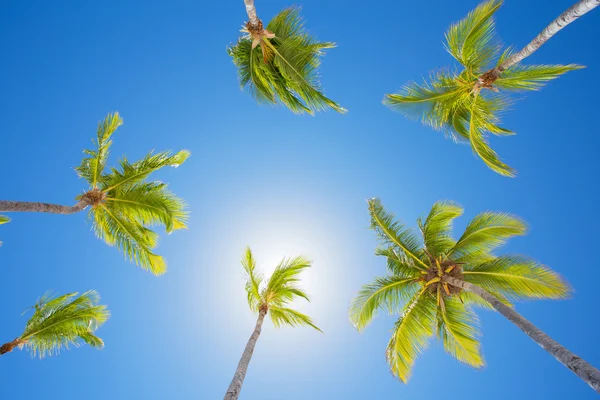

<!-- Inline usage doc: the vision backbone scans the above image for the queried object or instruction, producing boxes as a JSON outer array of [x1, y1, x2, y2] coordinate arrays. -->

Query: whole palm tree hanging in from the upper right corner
[[384, 0, 598, 177]]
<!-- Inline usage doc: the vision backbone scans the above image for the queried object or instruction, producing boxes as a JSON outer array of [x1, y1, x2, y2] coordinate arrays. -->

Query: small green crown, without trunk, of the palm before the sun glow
[[242, 248, 321, 332]]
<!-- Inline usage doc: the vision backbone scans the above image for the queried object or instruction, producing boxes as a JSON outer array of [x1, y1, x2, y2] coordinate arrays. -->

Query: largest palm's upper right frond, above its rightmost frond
[[448, 211, 527, 258]]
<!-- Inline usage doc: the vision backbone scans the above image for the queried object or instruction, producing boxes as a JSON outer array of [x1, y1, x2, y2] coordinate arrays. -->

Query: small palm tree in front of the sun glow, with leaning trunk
[[225, 248, 321, 400]]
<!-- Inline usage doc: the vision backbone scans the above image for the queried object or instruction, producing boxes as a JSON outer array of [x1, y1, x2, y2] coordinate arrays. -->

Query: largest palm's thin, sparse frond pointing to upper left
[[368, 199, 427, 270]]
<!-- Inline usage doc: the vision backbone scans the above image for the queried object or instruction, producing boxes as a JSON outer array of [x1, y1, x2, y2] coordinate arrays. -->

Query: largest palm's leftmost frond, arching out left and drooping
[[350, 276, 421, 331]]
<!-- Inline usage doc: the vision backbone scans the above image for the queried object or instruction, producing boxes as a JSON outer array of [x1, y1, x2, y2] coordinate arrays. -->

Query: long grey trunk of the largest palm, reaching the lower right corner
[[444, 276, 600, 393]]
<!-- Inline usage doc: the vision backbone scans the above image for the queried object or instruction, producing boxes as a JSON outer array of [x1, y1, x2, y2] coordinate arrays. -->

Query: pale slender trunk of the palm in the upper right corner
[[477, 0, 600, 88]]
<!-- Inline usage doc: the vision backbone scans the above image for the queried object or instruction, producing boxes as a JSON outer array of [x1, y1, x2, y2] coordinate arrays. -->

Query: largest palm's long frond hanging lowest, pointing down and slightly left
[[386, 291, 436, 383]]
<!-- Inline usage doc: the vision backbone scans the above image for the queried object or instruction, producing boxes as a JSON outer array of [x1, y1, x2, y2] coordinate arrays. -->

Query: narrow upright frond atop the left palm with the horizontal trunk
[[76, 112, 123, 188]]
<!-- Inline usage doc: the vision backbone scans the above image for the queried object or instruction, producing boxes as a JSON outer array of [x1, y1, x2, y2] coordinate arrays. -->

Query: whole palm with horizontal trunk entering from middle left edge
[[0, 113, 190, 275]]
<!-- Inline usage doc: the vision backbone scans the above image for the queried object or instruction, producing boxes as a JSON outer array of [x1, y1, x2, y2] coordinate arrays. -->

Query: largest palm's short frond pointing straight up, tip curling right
[[418, 201, 463, 257]]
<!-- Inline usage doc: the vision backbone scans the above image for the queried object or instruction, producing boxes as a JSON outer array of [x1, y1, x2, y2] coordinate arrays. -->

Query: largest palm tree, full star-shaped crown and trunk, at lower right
[[350, 199, 600, 391]]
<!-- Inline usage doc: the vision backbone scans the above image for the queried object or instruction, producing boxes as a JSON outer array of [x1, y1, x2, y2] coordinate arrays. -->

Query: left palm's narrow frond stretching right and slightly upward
[[100, 150, 190, 196]]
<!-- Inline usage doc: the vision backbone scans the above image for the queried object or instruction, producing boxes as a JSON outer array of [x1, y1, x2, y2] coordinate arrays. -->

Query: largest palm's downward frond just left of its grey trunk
[[438, 297, 484, 368]]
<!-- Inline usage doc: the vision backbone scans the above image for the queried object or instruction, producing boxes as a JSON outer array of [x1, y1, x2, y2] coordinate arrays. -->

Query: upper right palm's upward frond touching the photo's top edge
[[446, 0, 502, 73]]
